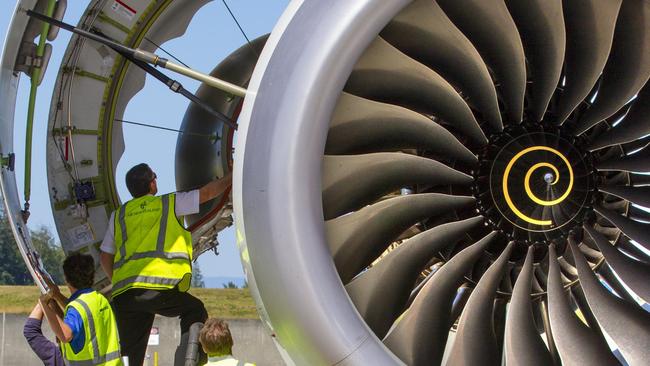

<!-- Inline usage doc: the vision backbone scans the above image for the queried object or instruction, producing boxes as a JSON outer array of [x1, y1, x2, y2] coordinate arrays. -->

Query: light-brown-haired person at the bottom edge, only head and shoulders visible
[[199, 318, 255, 366]]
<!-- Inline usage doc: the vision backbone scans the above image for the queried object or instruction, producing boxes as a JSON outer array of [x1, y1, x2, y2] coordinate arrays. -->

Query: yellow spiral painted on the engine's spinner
[[502, 146, 573, 226]]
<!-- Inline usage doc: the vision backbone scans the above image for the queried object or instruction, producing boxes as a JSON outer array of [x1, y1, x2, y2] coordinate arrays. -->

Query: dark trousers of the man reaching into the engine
[[112, 288, 208, 366]]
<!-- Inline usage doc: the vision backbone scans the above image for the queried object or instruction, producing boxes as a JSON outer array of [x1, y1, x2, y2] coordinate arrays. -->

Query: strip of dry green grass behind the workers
[[0, 286, 258, 319]]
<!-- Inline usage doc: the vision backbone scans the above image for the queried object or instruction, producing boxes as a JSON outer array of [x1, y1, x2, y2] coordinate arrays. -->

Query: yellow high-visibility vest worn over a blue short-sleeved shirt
[[61, 291, 123, 366]]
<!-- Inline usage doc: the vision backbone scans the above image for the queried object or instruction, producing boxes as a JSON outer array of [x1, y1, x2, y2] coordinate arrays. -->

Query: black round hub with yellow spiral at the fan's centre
[[477, 125, 593, 242]]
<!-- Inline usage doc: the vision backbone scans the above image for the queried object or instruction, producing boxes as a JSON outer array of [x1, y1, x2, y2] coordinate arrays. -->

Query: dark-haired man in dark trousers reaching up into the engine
[[100, 164, 231, 366]]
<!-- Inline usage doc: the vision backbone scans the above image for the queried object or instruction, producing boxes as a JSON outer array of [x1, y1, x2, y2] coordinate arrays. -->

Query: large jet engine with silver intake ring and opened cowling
[[0, 0, 650, 365]]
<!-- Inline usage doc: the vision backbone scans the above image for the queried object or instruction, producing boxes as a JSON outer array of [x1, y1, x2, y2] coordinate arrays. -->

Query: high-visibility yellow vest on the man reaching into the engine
[[113, 193, 192, 296]]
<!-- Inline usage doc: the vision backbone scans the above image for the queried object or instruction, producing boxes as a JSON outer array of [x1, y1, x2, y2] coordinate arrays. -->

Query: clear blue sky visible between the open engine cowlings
[[0, 0, 289, 276]]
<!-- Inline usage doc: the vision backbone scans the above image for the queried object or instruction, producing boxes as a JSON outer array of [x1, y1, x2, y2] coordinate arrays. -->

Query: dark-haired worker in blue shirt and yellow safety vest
[[40, 253, 123, 366]]
